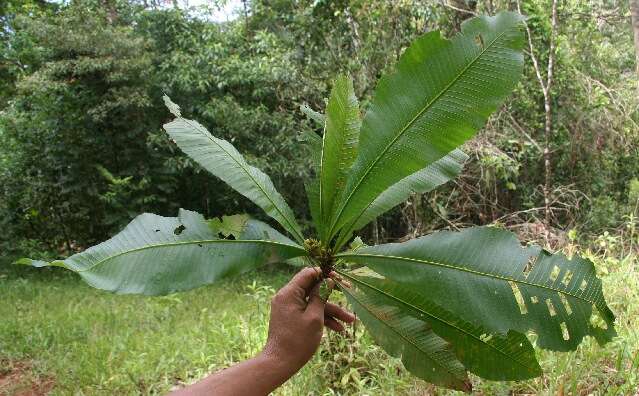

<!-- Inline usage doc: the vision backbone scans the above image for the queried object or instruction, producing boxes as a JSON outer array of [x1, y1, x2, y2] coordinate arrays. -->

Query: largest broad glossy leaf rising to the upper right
[[330, 12, 524, 238]]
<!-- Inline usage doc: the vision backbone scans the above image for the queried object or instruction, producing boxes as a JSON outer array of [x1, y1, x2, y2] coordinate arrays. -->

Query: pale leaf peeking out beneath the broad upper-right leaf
[[336, 150, 468, 250]]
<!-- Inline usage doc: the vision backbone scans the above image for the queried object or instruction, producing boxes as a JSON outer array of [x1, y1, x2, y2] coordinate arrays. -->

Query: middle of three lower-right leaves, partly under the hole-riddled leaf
[[339, 271, 541, 381]]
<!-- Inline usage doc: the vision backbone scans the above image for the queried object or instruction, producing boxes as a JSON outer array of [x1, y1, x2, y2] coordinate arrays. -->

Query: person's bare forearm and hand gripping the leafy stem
[[172, 268, 355, 396]]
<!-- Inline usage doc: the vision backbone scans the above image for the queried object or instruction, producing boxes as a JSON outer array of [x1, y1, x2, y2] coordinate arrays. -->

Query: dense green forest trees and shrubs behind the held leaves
[[0, 0, 639, 252]]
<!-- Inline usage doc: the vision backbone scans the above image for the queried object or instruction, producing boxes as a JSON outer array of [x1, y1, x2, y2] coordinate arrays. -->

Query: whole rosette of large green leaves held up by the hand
[[19, 12, 615, 391]]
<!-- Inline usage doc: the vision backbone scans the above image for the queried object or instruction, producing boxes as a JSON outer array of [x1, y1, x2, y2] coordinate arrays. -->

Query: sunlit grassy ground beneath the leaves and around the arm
[[0, 251, 639, 395]]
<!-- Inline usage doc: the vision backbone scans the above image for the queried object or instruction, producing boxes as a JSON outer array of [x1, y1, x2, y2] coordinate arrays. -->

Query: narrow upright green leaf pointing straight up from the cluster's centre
[[319, 76, 360, 242]]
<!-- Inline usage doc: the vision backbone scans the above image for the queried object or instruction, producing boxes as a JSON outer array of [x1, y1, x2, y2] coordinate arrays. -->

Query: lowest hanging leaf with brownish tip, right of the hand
[[338, 276, 472, 391]]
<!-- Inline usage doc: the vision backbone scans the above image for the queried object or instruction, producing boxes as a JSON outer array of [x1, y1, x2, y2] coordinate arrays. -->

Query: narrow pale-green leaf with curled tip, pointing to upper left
[[164, 95, 304, 243]]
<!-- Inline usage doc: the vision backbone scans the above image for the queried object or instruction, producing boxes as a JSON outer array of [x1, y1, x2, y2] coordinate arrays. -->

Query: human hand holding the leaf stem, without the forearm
[[263, 268, 355, 373]]
